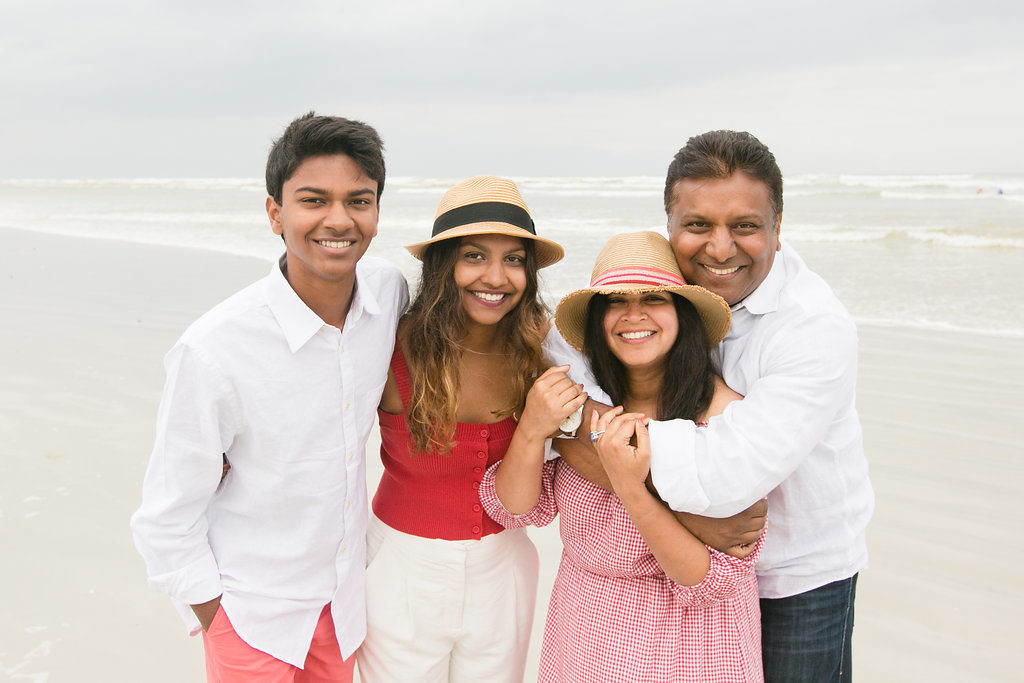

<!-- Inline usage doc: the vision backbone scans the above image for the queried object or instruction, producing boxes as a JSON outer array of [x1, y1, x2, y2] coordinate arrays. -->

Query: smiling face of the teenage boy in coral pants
[[266, 155, 380, 296]]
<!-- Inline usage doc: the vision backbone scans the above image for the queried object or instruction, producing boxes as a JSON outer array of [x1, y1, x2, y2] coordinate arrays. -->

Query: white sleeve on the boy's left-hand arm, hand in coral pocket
[[131, 343, 240, 604]]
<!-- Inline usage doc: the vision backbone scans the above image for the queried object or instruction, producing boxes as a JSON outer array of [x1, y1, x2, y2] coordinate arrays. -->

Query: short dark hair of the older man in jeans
[[665, 130, 782, 216]]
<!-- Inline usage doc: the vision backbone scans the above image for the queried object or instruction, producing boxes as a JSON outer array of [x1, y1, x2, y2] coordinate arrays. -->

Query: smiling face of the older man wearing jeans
[[669, 172, 782, 306]]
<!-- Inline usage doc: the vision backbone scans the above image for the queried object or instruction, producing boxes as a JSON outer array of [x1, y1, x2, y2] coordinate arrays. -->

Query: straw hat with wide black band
[[406, 175, 565, 268]]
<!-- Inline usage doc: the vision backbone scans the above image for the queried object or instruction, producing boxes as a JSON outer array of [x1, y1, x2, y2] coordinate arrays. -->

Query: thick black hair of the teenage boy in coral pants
[[266, 112, 384, 204]]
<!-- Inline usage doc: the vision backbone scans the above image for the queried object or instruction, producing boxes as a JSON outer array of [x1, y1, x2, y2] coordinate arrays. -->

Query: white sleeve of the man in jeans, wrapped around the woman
[[650, 315, 857, 517]]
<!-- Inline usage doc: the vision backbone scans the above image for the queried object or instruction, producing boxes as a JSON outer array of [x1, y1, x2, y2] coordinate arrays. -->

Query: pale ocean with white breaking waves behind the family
[[0, 174, 1024, 337]]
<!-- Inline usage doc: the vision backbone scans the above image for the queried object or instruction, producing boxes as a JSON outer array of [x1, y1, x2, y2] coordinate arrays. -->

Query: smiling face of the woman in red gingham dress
[[602, 292, 679, 370]]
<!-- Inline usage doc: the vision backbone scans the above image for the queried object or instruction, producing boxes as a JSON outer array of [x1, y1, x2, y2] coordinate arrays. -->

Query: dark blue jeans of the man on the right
[[761, 574, 857, 683]]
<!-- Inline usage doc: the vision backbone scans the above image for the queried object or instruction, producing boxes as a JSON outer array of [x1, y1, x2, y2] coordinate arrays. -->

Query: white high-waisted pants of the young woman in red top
[[356, 516, 538, 683]]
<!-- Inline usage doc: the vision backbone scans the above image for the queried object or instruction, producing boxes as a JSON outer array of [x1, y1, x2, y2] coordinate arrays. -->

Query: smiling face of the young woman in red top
[[453, 234, 526, 326]]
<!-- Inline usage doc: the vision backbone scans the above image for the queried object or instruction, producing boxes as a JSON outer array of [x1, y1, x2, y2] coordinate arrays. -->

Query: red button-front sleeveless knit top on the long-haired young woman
[[373, 344, 516, 541]]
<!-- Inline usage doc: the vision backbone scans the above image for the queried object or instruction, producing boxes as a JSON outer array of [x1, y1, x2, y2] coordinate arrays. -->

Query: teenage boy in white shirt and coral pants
[[132, 113, 409, 682]]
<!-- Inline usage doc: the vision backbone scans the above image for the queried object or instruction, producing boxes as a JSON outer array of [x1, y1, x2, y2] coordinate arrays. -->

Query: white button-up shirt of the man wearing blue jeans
[[546, 243, 874, 598]]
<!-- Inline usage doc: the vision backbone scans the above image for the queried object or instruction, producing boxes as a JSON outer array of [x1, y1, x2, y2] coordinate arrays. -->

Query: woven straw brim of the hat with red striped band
[[555, 285, 732, 351]]
